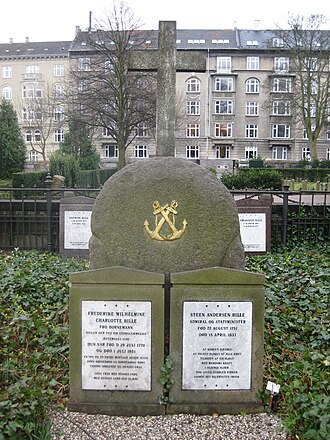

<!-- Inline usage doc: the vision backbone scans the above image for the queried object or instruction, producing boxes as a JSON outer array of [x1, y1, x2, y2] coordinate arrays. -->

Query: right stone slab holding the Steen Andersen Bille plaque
[[167, 267, 264, 414]]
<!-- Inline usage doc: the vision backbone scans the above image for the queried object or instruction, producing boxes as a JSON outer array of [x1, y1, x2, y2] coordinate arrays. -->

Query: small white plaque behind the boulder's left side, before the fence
[[64, 211, 92, 249]]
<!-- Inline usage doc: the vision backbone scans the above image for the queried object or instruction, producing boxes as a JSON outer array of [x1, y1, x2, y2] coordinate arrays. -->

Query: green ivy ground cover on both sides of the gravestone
[[0, 243, 330, 440]]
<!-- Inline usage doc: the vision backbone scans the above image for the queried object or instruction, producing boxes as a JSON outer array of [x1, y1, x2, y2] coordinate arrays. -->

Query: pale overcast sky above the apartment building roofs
[[0, 0, 330, 43]]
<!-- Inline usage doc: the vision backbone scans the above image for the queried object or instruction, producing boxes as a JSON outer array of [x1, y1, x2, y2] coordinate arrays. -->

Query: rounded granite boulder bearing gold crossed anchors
[[90, 157, 244, 273]]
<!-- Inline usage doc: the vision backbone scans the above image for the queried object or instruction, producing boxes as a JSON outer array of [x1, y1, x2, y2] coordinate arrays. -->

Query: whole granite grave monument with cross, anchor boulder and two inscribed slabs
[[69, 22, 263, 415]]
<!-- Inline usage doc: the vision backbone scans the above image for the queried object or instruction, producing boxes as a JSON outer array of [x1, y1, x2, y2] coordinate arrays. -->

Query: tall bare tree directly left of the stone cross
[[68, 2, 156, 169]]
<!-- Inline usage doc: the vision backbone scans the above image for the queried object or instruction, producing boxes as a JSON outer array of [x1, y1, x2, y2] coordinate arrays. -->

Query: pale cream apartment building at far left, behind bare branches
[[0, 38, 71, 169]]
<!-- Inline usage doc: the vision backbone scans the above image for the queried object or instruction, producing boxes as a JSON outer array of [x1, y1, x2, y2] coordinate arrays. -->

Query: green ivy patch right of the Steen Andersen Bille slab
[[247, 243, 330, 440]]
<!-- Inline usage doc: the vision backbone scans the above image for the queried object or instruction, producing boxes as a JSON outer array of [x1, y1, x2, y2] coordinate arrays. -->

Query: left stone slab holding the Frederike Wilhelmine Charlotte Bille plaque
[[68, 267, 165, 415]]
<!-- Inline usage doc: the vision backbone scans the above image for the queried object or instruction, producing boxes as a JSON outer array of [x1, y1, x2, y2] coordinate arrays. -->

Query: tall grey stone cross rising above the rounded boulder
[[130, 21, 206, 156]]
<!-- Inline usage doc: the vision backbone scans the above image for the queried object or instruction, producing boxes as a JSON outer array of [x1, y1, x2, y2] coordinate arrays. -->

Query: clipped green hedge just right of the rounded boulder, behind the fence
[[221, 168, 283, 190]]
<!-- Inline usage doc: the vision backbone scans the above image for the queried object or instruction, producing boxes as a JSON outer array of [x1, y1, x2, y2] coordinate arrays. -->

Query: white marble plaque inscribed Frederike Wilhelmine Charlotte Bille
[[81, 301, 151, 391]]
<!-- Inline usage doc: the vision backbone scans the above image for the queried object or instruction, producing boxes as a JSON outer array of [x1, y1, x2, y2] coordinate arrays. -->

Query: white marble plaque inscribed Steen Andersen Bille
[[182, 301, 252, 390]]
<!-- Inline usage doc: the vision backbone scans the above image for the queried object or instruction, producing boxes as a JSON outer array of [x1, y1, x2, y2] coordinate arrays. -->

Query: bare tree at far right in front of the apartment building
[[276, 15, 330, 160]]
